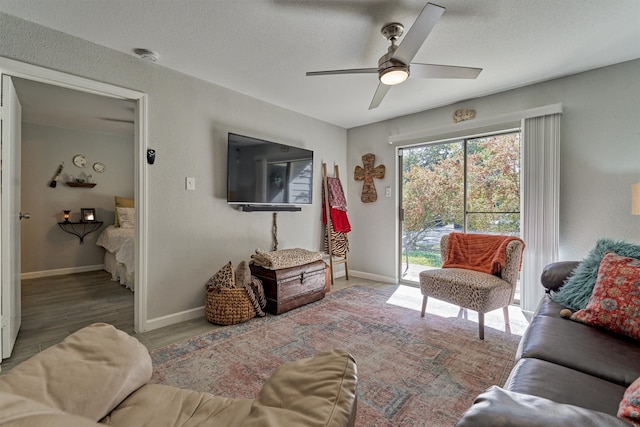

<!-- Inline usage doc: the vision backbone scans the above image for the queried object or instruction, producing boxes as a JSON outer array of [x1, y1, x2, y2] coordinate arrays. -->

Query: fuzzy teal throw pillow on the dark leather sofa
[[551, 239, 640, 311]]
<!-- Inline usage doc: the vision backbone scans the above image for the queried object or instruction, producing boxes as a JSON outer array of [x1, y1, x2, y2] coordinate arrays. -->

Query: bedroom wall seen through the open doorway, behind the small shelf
[[21, 123, 134, 275]]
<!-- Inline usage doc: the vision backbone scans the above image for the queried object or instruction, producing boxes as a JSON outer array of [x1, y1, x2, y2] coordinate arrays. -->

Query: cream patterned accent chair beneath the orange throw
[[420, 235, 523, 340]]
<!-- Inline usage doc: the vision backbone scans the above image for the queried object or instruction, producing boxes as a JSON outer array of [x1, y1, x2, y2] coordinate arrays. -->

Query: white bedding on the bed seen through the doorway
[[96, 225, 135, 290]]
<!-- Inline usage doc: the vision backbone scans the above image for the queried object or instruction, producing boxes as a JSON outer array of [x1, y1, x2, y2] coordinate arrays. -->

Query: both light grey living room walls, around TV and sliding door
[[0, 13, 640, 328]]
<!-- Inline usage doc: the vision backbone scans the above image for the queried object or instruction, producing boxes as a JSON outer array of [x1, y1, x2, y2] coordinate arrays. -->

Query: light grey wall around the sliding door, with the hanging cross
[[347, 60, 640, 280]]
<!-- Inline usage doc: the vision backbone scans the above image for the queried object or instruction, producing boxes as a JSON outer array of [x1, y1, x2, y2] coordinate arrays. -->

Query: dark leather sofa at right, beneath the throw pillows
[[457, 261, 640, 427]]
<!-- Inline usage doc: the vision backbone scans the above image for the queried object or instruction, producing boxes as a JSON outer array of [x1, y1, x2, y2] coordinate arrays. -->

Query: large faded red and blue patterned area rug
[[152, 286, 520, 427]]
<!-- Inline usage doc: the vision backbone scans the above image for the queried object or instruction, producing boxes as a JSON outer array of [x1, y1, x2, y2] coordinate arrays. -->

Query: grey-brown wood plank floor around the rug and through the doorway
[[0, 271, 395, 372]]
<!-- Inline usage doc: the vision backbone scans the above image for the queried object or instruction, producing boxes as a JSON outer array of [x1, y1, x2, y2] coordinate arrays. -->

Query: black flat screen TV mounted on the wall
[[227, 133, 313, 206]]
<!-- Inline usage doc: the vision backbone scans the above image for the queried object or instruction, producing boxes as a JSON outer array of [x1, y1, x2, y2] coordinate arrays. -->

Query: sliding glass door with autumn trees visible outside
[[399, 130, 520, 283]]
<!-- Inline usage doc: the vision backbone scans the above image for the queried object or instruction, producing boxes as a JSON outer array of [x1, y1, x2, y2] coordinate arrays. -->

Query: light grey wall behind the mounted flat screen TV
[[0, 13, 346, 326]]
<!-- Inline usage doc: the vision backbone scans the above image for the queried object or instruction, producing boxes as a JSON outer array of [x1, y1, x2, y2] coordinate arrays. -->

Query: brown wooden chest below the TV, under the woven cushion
[[250, 260, 328, 314]]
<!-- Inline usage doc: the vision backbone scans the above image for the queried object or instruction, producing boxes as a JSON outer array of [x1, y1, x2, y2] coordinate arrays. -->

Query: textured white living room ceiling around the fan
[[0, 0, 640, 128]]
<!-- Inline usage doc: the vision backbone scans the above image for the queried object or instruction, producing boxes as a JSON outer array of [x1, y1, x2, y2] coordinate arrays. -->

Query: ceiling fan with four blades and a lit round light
[[307, 3, 482, 110]]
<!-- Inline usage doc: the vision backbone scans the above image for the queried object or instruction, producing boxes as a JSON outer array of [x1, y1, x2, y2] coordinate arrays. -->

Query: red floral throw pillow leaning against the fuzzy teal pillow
[[571, 252, 640, 340]]
